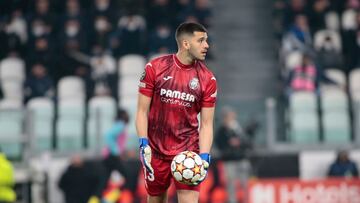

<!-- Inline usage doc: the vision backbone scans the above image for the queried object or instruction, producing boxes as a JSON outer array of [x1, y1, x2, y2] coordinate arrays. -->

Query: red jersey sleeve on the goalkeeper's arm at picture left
[[139, 63, 155, 97]]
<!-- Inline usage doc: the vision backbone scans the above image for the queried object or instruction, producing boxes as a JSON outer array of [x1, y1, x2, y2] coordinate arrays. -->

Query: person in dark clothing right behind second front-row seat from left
[[24, 63, 54, 103]]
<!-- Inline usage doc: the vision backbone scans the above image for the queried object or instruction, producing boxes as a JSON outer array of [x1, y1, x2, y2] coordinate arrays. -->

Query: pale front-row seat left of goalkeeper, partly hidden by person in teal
[[87, 96, 117, 149]]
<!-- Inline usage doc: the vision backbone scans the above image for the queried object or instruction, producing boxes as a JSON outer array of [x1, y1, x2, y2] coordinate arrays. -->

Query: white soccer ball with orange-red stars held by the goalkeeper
[[171, 151, 205, 185]]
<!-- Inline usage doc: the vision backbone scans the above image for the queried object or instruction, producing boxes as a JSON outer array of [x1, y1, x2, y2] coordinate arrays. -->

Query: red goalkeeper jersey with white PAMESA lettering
[[139, 54, 217, 159]]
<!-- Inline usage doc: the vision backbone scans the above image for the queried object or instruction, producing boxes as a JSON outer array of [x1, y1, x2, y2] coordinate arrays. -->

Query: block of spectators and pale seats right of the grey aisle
[[273, 0, 360, 143]]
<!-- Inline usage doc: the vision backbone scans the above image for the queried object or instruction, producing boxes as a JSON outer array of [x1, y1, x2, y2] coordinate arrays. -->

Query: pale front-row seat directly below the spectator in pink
[[290, 92, 319, 143]]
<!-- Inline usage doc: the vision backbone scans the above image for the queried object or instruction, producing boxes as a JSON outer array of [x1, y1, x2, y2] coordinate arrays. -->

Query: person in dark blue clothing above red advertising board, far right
[[328, 151, 359, 178]]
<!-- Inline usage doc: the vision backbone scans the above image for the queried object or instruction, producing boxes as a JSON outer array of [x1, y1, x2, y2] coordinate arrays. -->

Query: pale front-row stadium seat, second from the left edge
[[27, 97, 55, 152]]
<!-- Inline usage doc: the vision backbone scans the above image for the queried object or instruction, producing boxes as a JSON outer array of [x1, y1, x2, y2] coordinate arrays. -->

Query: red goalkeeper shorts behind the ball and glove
[[144, 156, 200, 196]]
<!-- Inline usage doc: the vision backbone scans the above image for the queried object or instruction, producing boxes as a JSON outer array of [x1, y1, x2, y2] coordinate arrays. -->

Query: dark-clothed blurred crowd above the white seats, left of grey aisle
[[0, 0, 211, 102]]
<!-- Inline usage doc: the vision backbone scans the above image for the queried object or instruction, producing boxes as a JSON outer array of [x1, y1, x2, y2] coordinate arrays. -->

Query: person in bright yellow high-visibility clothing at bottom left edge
[[0, 149, 16, 203]]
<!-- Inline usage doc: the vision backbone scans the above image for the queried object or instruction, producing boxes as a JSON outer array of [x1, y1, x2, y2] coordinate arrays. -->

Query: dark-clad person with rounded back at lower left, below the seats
[[58, 155, 105, 203]]
